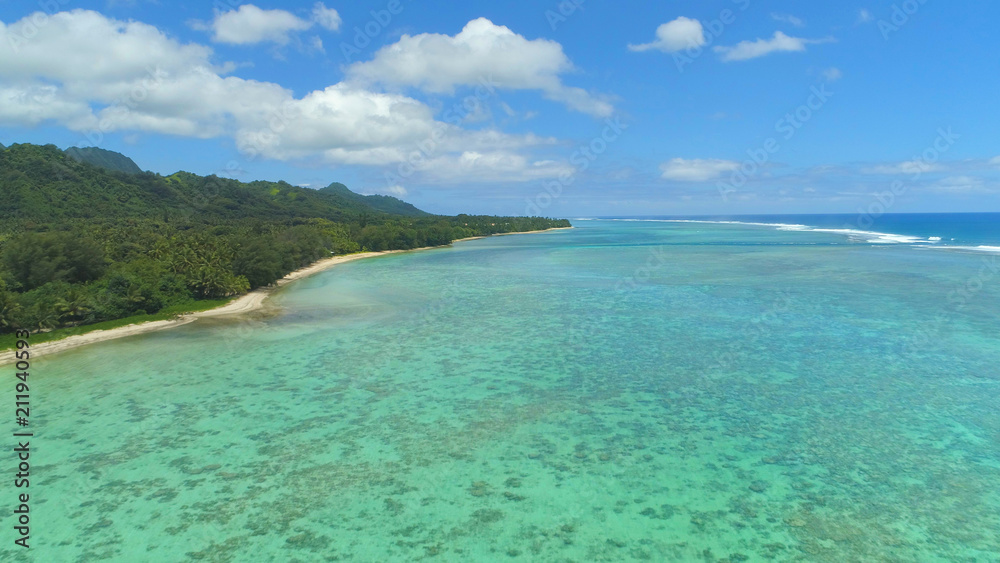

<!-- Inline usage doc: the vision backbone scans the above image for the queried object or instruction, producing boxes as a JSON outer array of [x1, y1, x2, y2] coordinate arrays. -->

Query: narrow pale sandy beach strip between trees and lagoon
[[0, 227, 573, 366]]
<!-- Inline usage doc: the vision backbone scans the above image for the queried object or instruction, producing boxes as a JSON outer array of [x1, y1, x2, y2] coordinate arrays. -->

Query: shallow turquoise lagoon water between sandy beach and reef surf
[[7, 221, 1000, 562]]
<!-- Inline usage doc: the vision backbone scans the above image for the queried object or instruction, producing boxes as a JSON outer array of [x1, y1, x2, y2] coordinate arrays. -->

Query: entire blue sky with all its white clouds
[[0, 0, 1000, 218]]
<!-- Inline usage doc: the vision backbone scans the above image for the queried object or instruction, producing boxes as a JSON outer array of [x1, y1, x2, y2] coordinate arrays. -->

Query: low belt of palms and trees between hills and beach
[[0, 216, 568, 333]]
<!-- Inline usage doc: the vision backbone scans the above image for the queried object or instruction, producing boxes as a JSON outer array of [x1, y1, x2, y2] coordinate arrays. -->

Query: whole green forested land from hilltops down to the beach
[[0, 144, 569, 333]]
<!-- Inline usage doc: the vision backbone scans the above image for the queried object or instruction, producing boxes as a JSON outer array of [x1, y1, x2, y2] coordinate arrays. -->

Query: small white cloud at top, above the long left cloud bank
[[203, 4, 313, 45]]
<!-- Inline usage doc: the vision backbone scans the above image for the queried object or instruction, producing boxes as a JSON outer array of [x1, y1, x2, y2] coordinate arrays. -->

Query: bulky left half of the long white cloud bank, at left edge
[[0, 10, 258, 136]]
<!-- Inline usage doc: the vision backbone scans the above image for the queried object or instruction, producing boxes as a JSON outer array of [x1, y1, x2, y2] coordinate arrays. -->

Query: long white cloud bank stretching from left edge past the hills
[[0, 10, 559, 181]]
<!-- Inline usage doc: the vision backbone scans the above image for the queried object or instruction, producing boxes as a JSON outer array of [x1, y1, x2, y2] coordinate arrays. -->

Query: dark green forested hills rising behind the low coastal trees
[[0, 144, 431, 222]]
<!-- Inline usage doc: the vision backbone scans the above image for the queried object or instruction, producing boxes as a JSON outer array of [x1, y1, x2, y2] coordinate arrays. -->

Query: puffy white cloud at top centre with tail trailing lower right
[[347, 18, 614, 117]]
